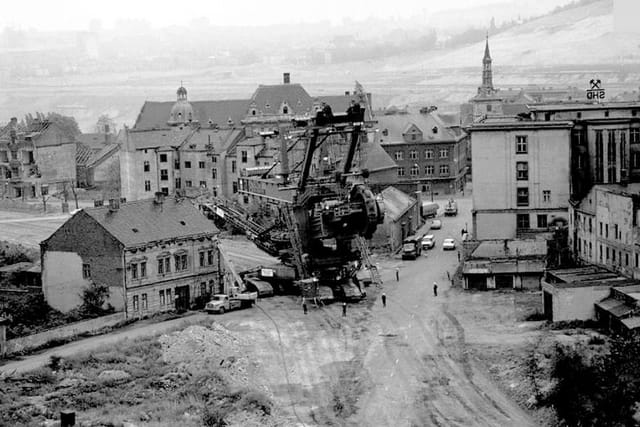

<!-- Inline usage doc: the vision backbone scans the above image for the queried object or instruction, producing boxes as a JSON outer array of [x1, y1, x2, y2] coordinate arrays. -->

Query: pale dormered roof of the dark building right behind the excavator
[[376, 112, 465, 145]]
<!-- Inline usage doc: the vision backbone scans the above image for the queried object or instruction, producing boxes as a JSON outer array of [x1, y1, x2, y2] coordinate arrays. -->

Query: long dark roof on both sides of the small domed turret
[[133, 99, 249, 130]]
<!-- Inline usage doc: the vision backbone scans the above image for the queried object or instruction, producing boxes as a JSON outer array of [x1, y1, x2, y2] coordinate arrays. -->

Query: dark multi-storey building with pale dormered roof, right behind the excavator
[[376, 112, 469, 194]]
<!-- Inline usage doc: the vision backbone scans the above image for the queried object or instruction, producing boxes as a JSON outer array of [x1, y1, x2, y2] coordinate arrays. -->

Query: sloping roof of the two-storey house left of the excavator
[[81, 197, 218, 246]]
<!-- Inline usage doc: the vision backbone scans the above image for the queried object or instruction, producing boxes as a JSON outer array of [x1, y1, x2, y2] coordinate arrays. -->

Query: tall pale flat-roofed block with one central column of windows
[[469, 118, 573, 240]]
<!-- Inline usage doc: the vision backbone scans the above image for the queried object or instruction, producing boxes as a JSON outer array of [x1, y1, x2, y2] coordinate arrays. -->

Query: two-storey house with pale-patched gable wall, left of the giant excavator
[[40, 193, 220, 317]]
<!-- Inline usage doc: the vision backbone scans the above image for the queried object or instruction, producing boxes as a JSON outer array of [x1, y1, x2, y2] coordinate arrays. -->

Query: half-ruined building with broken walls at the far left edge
[[0, 118, 76, 198]]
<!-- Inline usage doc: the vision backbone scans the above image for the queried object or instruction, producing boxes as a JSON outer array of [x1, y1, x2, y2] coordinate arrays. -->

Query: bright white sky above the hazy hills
[[0, 0, 569, 31]]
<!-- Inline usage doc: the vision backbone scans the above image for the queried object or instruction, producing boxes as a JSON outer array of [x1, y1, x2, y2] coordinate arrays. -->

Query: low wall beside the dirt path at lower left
[[0, 312, 125, 356]]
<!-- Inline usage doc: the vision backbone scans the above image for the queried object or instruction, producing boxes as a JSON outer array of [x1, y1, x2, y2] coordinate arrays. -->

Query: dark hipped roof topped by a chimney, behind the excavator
[[249, 83, 314, 115]]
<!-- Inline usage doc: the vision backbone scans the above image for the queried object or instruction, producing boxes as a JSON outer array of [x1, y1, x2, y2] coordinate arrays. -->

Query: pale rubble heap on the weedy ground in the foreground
[[159, 323, 255, 386]]
